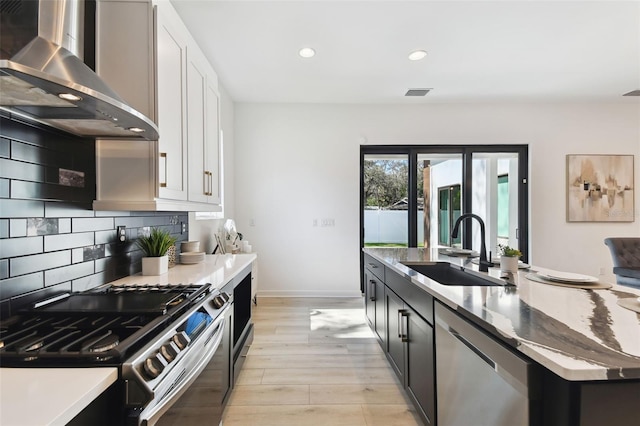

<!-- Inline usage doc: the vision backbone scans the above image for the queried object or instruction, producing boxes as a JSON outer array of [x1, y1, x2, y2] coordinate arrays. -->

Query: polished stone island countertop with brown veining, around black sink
[[364, 248, 640, 381]]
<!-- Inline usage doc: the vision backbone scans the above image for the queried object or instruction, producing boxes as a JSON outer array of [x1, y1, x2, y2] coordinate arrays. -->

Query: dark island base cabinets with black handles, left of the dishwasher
[[363, 254, 436, 425]]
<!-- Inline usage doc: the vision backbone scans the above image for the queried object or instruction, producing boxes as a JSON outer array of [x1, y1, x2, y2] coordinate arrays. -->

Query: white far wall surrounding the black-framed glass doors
[[235, 103, 640, 296]]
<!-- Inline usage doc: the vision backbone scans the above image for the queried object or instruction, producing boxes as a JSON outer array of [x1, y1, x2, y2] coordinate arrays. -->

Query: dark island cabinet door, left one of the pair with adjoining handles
[[385, 289, 406, 384]]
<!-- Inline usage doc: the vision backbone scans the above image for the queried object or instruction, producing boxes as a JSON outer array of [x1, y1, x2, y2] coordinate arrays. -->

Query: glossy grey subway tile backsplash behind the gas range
[[0, 116, 188, 317]]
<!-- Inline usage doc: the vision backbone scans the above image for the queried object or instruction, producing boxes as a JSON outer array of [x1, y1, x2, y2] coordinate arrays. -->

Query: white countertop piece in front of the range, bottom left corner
[[0, 367, 118, 426]]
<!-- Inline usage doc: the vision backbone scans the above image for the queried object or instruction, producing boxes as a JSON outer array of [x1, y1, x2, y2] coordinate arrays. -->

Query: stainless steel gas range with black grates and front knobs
[[0, 284, 233, 425]]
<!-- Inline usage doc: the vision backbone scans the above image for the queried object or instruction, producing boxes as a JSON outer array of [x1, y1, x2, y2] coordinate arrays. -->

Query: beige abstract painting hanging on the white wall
[[566, 154, 635, 222]]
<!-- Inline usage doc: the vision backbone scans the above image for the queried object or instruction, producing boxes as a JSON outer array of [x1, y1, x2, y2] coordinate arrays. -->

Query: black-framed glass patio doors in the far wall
[[360, 145, 529, 278]]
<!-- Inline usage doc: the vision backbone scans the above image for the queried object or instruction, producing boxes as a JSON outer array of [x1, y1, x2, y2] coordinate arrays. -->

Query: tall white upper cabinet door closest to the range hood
[[156, 6, 188, 200]]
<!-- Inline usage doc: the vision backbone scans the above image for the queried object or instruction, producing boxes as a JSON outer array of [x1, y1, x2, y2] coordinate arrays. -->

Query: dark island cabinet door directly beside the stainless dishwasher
[[408, 306, 436, 425]]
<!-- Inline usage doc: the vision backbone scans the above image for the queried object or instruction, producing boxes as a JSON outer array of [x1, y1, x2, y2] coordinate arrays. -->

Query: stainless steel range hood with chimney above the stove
[[0, 0, 158, 140]]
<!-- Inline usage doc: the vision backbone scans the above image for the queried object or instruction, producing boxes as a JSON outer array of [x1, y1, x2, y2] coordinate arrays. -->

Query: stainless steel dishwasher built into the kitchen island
[[435, 303, 541, 426]]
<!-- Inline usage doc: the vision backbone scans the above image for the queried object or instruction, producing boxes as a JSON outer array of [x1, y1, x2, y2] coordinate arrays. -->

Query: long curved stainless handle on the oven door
[[139, 315, 226, 426]]
